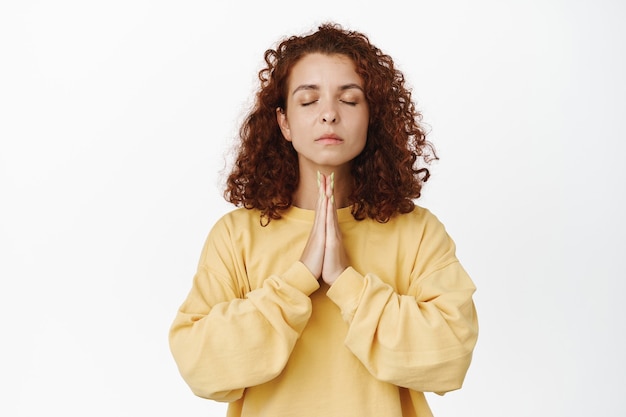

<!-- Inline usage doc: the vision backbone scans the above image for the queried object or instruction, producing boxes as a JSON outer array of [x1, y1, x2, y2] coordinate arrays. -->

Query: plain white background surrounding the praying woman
[[0, 0, 626, 417]]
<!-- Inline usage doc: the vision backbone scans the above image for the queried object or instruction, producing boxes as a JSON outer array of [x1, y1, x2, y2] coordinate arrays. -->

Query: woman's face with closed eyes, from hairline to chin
[[276, 53, 369, 171]]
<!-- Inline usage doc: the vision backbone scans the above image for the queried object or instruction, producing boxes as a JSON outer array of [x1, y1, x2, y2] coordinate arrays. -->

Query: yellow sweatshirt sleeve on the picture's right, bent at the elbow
[[327, 211, 478, 393]]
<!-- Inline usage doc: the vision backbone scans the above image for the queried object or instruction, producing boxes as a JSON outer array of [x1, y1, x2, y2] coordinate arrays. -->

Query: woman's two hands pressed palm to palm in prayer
[[300, 174, 348, 285]]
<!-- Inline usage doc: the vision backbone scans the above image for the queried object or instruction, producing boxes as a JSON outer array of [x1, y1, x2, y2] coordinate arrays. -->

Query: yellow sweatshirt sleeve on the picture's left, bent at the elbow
[[169, 216, 319, 401]]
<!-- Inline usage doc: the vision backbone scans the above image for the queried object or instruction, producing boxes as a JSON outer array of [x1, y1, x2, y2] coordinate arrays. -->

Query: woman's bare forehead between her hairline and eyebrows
[[288, 53, 363, 91]]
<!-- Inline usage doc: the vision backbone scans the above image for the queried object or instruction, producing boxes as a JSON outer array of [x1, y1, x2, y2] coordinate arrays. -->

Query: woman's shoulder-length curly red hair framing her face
[[224, 23, 437, 224]]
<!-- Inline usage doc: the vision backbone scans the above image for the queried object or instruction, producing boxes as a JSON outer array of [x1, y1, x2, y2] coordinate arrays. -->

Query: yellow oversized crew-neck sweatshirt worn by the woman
[[169, 207, 478, 417]]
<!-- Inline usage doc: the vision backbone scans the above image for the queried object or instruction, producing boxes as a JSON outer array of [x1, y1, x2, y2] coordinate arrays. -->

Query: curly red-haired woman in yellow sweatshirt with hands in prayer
[[170, 24, 478, 417]]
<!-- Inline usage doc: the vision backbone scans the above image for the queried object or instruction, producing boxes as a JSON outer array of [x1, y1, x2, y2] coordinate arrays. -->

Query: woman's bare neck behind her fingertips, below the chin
[[293, 166, 352, 210]]
